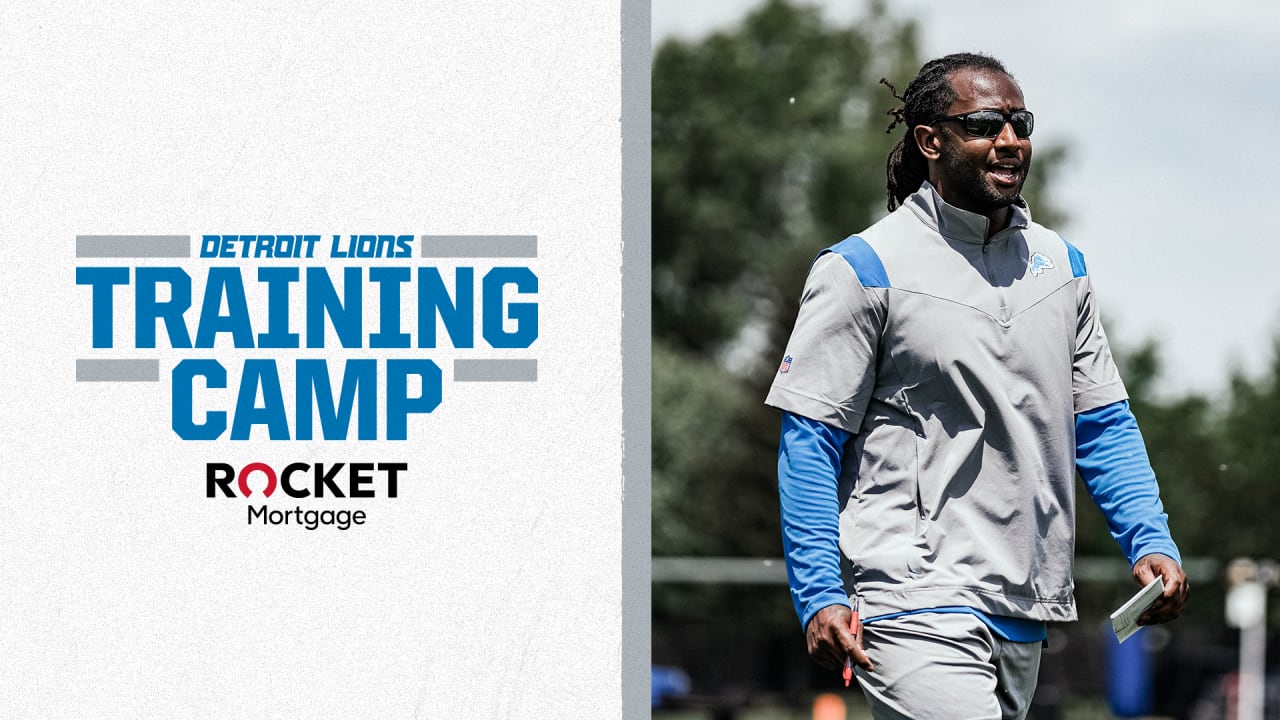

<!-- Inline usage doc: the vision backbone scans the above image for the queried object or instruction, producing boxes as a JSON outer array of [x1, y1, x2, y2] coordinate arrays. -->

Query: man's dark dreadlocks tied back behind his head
[[881, 53, 1012, 211]]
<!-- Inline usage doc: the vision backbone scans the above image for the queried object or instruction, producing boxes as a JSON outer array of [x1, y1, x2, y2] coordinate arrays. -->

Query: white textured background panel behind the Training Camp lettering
[[0, 0, 622, 719]]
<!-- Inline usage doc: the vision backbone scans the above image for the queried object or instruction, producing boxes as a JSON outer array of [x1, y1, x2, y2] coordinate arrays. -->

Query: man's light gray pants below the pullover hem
[[856, 604, 1042, 720]]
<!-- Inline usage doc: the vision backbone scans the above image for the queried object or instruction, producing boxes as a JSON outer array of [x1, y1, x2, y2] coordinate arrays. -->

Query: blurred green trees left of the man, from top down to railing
[[653, 0, 919, 566]]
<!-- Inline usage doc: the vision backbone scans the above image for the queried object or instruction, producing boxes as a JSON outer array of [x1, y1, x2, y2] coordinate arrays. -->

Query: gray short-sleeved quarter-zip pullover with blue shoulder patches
[[767, 183, 1176, 621]]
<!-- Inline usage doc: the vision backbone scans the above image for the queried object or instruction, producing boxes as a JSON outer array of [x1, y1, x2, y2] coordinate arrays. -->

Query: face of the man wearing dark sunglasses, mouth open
[[933, 69, 1032, 217]]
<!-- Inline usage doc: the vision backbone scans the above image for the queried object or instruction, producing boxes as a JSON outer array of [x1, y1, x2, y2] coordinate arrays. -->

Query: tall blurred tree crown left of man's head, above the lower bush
[[653, 0, 918, 356]]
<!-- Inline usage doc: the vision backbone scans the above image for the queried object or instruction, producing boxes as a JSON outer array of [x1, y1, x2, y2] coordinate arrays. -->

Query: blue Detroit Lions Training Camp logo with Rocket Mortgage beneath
[[76, 233, 539, 530]]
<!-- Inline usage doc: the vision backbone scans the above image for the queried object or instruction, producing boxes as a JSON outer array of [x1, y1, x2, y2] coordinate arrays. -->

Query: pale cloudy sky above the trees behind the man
[[652, 0, 1280, 396]]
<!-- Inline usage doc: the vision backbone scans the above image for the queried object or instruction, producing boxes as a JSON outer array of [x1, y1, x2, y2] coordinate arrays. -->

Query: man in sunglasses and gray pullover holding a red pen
[[767, 54, 1189, 720]]
